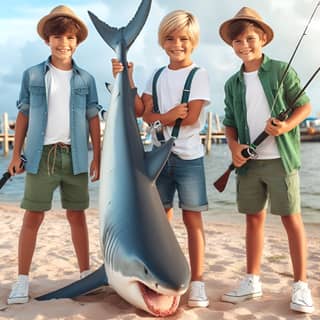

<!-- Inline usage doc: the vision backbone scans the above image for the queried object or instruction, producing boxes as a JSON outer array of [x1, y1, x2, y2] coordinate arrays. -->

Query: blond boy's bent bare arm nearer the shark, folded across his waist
[[142, 93, 188, 126]]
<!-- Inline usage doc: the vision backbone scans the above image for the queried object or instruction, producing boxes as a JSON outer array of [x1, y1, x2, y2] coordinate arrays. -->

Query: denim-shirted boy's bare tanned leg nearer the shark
[[67, 210, 89, 272]]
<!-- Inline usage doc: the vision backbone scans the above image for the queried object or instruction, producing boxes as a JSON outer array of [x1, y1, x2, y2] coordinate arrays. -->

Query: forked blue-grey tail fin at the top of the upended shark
[[88, 0, 152, 51]]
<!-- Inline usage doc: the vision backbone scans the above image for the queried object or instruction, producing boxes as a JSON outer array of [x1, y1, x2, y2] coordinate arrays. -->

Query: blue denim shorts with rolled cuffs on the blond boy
[[157, 153, 208, 212]]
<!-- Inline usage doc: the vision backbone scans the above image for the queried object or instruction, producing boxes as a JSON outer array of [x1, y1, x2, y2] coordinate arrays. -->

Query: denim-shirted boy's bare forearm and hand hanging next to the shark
[[89, 115, 101, 182]]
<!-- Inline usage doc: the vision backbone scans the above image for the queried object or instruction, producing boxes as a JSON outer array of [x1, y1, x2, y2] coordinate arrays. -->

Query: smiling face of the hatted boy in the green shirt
[[232, 28, 267, 67]]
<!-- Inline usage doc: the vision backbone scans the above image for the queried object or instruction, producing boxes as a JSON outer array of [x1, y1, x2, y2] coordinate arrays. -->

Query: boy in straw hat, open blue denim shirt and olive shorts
[[8, 5, 100, 304]]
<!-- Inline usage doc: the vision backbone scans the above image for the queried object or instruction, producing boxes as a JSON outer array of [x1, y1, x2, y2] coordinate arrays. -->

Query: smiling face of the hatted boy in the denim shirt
[[47, 32, 78, 64]]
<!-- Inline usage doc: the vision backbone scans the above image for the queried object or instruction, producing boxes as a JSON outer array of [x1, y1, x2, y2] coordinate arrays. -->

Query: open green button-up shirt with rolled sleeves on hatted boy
[[223, 55, 309, 174]]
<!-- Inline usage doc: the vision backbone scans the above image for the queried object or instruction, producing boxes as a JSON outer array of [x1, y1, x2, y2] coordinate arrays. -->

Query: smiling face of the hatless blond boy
[[163, 29, 193, 69]]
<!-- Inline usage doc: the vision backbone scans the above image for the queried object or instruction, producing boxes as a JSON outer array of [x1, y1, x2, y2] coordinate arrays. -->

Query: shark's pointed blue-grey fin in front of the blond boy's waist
[[145, 138, 174, 181]]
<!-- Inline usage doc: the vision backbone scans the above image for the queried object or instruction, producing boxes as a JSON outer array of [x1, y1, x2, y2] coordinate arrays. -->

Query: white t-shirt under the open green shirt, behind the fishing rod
[[243, 71, 280, 159]]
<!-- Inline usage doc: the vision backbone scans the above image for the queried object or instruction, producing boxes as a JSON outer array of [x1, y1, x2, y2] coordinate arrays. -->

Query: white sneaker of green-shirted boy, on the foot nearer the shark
[[221, 274, 262, 303]]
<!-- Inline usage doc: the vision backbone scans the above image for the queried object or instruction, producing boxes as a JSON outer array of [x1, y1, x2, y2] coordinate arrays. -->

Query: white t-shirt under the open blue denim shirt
[[44, 64, 72, 145]]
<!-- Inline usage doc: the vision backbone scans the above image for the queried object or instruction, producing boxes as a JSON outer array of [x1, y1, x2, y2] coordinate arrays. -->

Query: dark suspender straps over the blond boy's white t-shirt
[[152, 67, 199, 141]]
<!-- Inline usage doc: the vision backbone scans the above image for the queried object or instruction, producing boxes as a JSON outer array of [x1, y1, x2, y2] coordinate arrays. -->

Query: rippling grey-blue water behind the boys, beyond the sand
[[0, 143, 320, 223]]
